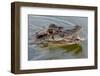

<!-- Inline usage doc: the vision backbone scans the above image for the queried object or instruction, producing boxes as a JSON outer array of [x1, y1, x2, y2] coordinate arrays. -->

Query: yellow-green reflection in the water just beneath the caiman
[[41, 44, 82, 55]]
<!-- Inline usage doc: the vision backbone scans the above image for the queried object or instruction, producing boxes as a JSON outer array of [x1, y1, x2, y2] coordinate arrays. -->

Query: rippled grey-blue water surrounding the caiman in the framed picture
[[28, 15, 88, 60]]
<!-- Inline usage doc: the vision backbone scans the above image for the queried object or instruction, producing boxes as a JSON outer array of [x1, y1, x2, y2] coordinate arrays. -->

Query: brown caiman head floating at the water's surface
[[35, 25, 83, 46]]
